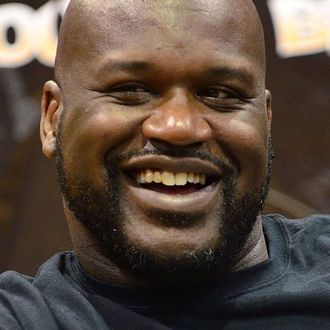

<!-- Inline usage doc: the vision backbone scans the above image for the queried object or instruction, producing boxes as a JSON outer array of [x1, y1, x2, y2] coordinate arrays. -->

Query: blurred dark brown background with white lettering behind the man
[[0, 0, 330, 274]]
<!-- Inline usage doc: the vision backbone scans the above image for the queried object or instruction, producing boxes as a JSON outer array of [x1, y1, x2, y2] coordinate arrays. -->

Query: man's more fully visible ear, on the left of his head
[[40, 81, 63, 158]]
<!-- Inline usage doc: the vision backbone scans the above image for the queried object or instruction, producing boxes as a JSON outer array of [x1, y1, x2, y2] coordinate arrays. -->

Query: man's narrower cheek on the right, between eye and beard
[[210, 113, 268, 191]]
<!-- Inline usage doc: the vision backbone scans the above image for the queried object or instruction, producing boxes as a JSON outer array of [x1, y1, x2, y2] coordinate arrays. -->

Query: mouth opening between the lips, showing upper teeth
[[129, 168, 217, 195]]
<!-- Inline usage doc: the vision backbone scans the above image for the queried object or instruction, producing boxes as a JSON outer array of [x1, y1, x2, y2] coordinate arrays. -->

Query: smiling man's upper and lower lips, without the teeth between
[[121, 155, 221, 215]]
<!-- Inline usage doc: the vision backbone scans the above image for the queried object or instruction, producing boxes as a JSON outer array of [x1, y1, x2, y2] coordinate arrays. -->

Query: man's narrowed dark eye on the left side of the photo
[[107, 83, 155, 105]]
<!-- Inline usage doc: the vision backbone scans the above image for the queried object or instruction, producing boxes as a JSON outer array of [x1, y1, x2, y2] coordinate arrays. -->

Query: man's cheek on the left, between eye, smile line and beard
[[62, 106, 147, 185]]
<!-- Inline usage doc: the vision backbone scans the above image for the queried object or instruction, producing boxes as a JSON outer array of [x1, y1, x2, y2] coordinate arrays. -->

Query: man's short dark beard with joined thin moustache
[[55, 128, 273, 287]]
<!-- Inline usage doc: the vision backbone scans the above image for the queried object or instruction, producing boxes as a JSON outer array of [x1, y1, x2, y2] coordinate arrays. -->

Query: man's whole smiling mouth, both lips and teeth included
[[120, 155, 224, 215]]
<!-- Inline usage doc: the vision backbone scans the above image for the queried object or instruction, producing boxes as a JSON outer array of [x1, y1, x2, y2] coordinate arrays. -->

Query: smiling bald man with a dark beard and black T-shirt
[[0, 0, 330, 329]]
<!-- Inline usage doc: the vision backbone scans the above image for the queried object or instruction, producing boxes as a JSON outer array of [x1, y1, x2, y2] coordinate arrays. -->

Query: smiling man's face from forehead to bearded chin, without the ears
[[56, 1, 269, 284]]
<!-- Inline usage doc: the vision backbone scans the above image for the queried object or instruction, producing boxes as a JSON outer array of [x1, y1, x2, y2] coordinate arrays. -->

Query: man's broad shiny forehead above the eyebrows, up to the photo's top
[[56, 0, 263, 82]]
